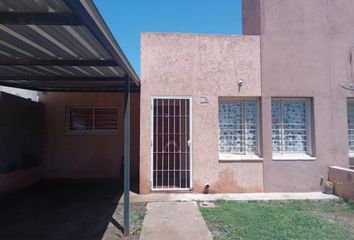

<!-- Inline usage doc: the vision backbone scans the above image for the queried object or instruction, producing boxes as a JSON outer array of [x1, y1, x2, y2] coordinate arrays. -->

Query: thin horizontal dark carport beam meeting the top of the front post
[[0, 75, 125, 82]]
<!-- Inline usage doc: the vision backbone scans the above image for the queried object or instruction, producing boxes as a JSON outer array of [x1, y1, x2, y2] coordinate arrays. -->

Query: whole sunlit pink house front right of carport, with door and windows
[[140, 0, 354, 193]]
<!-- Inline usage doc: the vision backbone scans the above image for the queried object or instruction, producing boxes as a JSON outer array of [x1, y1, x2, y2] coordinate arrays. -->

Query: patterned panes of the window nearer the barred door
[[219, 99, 258, 155]]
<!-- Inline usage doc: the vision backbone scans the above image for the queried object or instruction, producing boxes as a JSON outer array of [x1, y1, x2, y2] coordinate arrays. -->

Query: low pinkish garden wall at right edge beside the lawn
[[328, 167, 354, 200]]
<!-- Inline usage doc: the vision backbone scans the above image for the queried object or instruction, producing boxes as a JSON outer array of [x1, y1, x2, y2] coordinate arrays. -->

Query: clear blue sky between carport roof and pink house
[[94, 0, 242, 76]]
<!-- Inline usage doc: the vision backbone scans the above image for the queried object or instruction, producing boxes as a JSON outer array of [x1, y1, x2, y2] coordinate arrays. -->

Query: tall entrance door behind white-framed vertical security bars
[[152, 98, 191, 190]]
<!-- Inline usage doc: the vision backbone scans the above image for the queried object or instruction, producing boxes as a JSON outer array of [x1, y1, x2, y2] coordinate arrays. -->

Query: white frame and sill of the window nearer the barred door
[[218, 98, 263, 161]]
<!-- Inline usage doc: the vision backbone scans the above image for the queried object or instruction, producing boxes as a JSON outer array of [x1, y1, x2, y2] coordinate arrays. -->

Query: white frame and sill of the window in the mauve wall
[[271, 97, 316, 160]]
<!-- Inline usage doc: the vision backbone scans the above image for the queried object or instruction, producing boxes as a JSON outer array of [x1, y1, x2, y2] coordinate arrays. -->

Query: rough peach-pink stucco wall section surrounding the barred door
[[140, 33, 263, 193]]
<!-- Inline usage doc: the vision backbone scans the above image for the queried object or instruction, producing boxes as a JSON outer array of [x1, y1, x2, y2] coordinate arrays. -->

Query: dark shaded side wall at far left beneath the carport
[[0, 92, 44, 194]]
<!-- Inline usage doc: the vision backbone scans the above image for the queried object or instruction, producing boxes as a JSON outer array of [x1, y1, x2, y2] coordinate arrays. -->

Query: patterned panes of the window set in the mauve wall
[[272, 99, 311, 154]]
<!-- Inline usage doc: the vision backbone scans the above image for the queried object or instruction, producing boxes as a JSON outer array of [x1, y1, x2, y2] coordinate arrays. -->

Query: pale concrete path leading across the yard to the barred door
[[140, 202, 212, 240]]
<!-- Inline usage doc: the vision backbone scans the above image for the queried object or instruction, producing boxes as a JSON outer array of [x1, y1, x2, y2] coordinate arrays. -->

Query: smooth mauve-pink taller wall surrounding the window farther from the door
[[244, 0, 354, 192]]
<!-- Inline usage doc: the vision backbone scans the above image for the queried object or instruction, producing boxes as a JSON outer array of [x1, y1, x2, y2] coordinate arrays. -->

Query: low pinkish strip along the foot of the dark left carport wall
[[0, 166, 42, 195]]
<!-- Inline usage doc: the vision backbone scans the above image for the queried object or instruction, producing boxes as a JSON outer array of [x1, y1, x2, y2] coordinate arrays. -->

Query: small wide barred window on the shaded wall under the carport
[[67, 108, 118, 132]]
